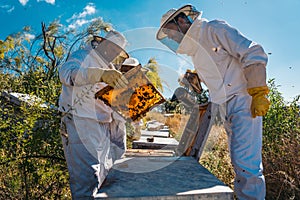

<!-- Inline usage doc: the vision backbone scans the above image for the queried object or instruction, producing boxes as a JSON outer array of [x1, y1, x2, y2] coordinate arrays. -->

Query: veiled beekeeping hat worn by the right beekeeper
[[156, 5, 201, 53]]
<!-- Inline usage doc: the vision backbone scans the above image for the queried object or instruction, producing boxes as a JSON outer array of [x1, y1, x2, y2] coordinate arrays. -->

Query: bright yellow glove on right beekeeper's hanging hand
[[248, 86, 270, 118]]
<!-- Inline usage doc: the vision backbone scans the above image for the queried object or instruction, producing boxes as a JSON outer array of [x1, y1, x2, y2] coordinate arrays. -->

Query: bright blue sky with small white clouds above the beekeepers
[[0, 0, 300, 101]]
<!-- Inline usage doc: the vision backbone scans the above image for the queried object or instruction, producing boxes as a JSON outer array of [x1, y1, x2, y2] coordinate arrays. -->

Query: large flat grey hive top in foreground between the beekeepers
[[97, 156, 233, 200]]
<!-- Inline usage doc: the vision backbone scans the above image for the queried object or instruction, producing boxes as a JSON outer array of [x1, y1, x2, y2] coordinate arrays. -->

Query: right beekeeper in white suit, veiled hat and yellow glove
[[157, 5, 269, 199]]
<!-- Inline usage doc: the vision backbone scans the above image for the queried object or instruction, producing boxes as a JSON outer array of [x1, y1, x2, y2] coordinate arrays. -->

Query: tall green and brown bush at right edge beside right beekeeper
[[263, 79, 300, 199]]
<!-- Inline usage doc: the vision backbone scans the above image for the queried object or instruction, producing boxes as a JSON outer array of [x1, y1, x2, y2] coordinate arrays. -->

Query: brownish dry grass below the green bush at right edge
[[263, 133, 300, 199]]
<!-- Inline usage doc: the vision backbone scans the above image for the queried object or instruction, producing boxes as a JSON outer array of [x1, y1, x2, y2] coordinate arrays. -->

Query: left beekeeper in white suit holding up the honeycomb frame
[[59, 31, 126, 199]]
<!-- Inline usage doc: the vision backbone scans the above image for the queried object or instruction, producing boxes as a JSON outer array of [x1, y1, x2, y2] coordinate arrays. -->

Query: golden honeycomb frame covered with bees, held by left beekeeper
[[95, 65, 165, 121]]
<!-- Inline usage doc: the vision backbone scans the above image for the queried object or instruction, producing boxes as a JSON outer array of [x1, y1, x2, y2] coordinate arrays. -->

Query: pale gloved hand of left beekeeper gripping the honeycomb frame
[[87, 68, 128, 88]]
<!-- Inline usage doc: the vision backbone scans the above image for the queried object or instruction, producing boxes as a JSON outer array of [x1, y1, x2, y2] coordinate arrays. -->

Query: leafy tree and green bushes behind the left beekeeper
[[0, 19, 111, 199]]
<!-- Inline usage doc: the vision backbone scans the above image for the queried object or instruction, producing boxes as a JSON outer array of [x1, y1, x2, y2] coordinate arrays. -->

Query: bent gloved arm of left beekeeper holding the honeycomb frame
[[59, 52, 128, 88]]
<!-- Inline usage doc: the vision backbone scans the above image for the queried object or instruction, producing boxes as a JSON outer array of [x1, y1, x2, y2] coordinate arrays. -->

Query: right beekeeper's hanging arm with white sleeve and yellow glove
[[211, 20, 270, 117]]
